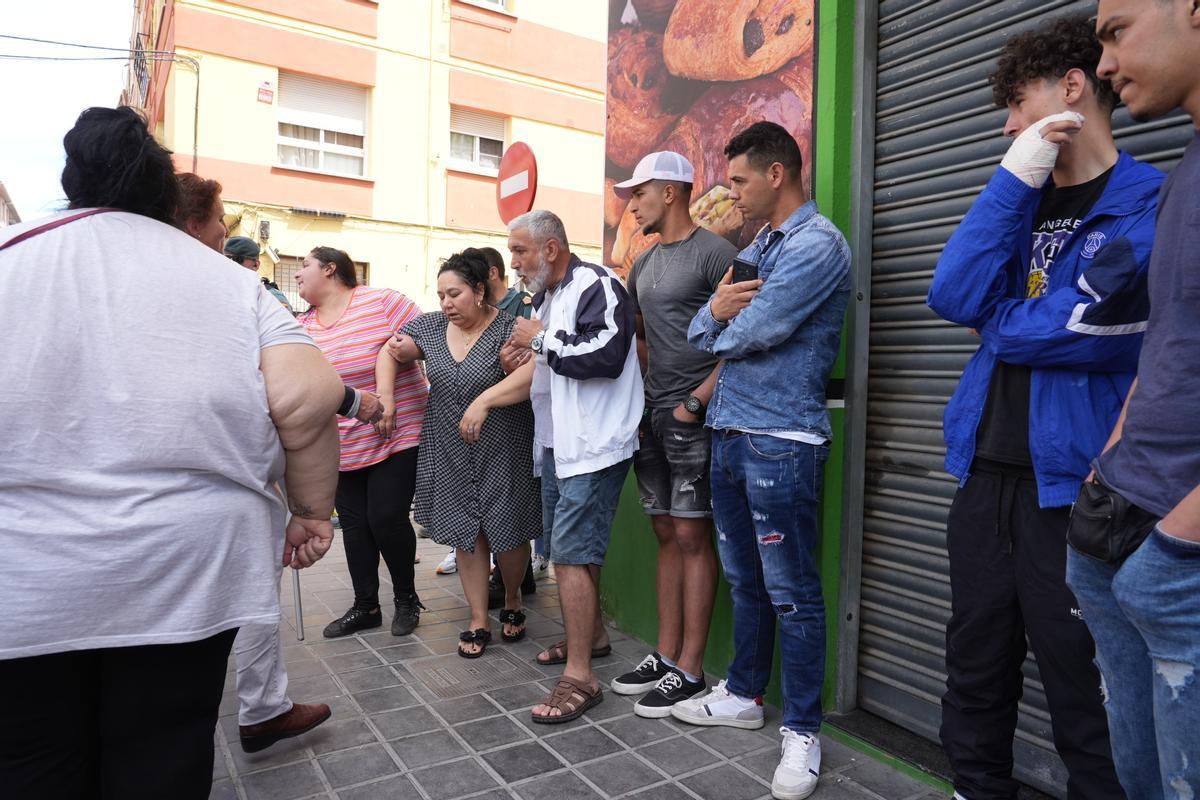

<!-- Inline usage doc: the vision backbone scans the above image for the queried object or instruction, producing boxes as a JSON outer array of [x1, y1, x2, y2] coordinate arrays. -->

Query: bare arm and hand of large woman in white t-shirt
[[259, 344, 344, 569]]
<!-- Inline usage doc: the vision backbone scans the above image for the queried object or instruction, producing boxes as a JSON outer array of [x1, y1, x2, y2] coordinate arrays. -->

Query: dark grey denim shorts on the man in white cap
[[634, 408, 713, 518]]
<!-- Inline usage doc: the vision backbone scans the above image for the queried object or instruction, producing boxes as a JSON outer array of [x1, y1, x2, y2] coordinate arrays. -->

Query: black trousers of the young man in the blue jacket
[[941, 459, 1126, 800]]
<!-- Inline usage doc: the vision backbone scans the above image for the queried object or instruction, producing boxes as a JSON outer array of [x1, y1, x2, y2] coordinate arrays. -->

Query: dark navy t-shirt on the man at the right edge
[[1097, 134, 1200, 515]]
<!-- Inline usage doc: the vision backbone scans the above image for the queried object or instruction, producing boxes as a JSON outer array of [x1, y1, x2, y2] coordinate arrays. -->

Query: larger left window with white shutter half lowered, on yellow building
[[276, 72, 367, 175]]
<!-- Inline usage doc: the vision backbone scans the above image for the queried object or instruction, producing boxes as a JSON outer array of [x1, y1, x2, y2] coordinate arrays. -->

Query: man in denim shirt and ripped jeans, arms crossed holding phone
[[672, 122, 850, 800]]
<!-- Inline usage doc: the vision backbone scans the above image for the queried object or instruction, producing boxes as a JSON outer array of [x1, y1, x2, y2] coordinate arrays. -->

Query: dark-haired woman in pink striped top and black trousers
[[296, 247, 428, 639]]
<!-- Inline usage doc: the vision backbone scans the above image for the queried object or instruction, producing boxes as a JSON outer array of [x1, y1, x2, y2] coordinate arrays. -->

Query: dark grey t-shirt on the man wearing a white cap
[[626, 228, 738, 408]]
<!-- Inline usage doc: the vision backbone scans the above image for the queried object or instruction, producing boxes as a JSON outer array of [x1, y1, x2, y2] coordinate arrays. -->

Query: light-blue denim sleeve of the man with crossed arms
[[688, 230, 850, 359]]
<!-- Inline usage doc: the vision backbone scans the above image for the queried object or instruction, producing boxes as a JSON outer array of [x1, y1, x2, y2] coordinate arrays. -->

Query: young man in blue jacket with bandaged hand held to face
[[928, 18, 1163, 800]]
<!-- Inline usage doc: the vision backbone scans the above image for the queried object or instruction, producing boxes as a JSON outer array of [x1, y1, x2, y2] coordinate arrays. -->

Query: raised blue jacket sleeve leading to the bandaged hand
[[925, 167, 1042, 329]]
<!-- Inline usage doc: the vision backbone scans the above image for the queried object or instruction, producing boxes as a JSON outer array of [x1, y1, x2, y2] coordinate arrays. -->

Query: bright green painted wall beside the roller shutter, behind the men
[[601, 0, 854, 706]]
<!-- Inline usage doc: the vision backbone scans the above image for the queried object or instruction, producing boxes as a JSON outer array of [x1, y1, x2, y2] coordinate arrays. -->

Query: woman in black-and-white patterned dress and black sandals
[[388, 253, 541, 658]]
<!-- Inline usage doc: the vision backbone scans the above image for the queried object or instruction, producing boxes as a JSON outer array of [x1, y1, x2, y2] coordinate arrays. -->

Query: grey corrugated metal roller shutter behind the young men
[[858, 0, 1192, 796]]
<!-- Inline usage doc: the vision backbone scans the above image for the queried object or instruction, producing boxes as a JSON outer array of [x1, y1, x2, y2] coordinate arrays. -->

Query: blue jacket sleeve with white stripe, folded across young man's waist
[[979, 203, 1156, 372]]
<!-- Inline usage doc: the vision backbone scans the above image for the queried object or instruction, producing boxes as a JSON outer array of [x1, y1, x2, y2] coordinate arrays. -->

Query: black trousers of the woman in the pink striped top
[[336, 447, 416, 610]]
